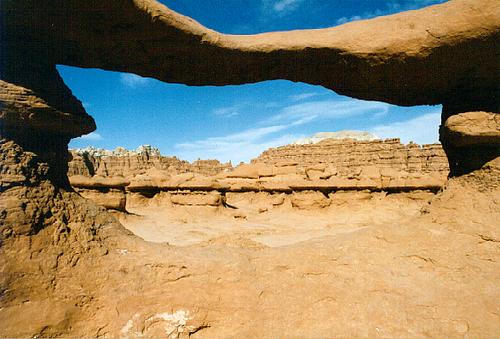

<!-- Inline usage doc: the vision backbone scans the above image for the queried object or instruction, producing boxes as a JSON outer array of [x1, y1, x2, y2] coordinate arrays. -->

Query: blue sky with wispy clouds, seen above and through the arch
[[62, 0, 444, 164]]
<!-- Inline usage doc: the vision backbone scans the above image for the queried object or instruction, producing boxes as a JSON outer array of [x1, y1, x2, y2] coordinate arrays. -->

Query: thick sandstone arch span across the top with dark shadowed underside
[[0, 0, 500, 177]]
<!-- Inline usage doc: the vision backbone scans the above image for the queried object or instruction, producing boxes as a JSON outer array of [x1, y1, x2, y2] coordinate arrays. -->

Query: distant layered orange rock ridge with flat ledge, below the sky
[[68, 139, 449, 211]]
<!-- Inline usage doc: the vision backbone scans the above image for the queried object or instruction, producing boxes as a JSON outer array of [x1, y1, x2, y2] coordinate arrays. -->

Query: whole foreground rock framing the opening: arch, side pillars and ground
[[0, 0, 500, 338]]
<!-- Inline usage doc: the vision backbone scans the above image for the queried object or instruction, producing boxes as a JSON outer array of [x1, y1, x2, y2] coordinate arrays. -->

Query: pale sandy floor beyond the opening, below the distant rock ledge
[[115, 192, 434, 247]]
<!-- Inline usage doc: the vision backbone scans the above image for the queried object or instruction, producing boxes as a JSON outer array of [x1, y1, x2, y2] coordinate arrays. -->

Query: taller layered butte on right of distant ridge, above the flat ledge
[[252, 139, 449, 179]]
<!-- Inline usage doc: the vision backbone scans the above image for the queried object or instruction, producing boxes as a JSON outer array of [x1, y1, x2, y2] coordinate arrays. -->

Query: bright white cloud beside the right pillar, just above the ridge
[[369, 112, 441, 145]]
